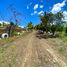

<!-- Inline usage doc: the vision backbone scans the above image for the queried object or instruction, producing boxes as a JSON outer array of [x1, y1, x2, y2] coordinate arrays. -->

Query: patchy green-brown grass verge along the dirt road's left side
[[0, 32, 29, 67]]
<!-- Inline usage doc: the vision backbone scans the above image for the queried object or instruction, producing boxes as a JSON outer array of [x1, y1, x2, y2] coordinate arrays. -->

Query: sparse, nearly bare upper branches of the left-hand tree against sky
[[8, 5, 22, 25]]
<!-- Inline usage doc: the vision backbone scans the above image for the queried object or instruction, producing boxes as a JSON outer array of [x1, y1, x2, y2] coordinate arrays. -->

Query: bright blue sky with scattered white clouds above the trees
[[0, 0, 67, 26]]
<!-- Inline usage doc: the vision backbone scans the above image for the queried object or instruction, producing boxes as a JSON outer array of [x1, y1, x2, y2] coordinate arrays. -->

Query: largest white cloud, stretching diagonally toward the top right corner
[[51, 0, 66, 13]]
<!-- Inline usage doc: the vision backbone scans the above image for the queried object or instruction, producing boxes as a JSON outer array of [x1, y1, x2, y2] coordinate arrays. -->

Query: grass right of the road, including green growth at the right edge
[[45, 32, 67, 60]]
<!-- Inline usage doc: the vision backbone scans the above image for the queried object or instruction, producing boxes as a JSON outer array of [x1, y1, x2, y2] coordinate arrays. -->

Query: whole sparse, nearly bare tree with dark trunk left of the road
[[7, 5, 22, 36]]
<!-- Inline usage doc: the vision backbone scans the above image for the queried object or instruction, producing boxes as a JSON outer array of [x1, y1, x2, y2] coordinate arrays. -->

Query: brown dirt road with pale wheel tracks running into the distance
[[0, 32, 67, 67]]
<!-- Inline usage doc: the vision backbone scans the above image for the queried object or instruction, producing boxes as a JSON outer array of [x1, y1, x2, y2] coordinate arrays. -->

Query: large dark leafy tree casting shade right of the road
[[40, 12, 64, 35]]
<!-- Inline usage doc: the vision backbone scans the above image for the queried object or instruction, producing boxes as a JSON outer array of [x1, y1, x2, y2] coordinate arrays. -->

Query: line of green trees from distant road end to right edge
[[28, 12, 67, 36]]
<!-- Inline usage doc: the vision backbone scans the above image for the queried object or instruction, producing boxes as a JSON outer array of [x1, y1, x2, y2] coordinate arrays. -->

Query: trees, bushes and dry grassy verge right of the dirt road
[[35, 12, 67, 60]]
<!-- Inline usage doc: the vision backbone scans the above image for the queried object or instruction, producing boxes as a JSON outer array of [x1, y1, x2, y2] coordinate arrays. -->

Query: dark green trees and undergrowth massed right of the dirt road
[[35, 12, 67, 38]]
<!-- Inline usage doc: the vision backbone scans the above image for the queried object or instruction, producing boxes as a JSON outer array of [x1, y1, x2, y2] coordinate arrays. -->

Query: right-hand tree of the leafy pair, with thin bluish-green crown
[[51, 12, 64, 35]]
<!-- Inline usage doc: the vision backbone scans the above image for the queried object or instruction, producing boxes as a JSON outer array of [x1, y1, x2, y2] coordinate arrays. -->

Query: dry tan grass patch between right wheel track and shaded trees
[[46, 38, 67, 63]]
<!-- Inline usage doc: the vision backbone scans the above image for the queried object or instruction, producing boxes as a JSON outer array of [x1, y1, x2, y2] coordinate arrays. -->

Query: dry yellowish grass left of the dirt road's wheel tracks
[[0, 32, 28, 67]]
